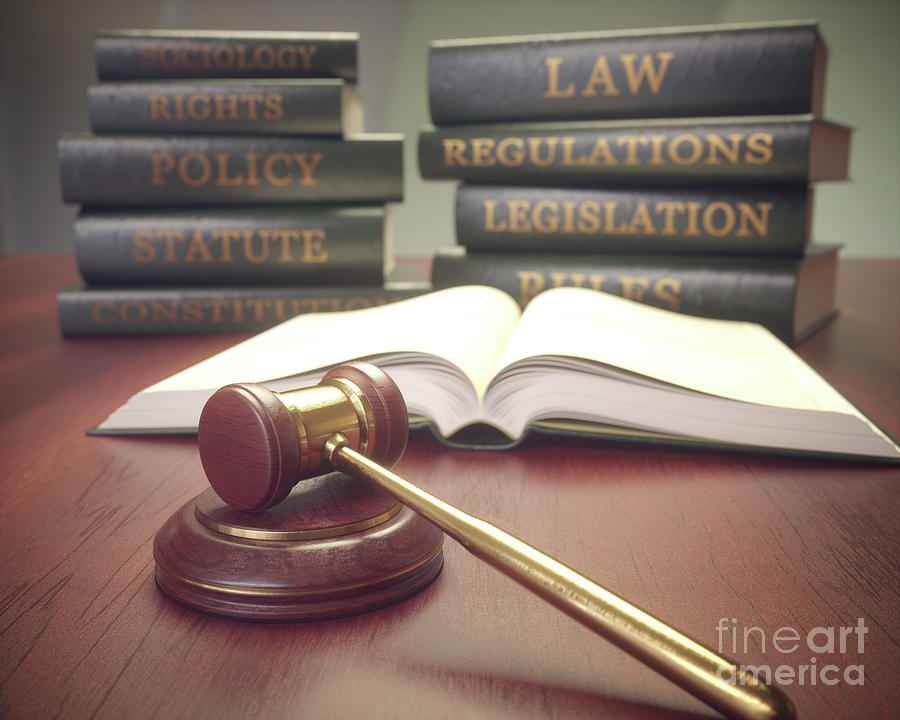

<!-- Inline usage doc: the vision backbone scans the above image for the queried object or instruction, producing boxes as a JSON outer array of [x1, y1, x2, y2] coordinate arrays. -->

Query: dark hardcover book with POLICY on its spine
[[58, 134, 403, 205]]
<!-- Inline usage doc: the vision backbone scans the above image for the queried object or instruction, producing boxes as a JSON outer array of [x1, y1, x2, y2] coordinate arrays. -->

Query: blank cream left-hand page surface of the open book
[[145, 286, 520, 398]]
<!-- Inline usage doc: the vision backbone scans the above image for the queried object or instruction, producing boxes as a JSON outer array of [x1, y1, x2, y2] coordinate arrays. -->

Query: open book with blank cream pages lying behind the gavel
[[95, 286, 900, 459]]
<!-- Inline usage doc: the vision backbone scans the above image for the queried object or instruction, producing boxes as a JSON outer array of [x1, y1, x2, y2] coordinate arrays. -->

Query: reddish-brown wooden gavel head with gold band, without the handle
[[198, 363, 409, 512]]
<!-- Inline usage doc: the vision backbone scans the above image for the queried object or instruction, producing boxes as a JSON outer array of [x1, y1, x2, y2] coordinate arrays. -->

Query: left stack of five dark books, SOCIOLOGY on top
[[58, 31, 424, 335]]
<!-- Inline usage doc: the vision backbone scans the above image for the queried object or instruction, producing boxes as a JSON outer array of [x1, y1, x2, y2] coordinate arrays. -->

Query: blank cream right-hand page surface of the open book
[[499, 288, 858, 414]]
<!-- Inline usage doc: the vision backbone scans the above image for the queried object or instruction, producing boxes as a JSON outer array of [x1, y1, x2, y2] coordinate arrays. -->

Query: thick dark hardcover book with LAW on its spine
[[428, 21, 826, 125]]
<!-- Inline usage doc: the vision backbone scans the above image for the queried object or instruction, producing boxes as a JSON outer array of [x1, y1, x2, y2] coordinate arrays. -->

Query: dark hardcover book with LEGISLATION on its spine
[[456, 185, 812, 256]]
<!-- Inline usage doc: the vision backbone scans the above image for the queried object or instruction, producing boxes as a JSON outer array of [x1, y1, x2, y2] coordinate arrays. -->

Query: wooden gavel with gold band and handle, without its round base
[[171, 363, 794, 720]]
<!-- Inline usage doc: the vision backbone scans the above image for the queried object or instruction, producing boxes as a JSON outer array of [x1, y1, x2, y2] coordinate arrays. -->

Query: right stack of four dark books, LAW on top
[[419, 16, 850, 343]]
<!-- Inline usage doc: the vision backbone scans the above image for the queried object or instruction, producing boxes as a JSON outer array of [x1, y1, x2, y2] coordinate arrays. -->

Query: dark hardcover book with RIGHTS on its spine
[[88, 79, 364, 135]]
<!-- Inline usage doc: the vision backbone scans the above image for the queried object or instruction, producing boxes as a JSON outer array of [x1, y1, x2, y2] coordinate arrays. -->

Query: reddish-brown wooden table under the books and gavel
[[0, 256, 900, 720]]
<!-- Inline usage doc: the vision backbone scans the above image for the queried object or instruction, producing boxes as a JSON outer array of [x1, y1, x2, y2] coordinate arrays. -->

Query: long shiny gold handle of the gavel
[[324, 434, 794, 720]]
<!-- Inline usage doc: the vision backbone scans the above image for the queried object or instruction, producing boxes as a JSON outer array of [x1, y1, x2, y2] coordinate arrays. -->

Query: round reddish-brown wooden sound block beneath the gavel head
[[153, 473, 443, 621]]
